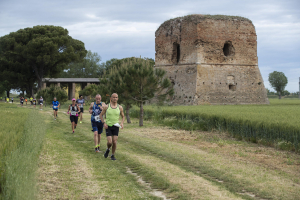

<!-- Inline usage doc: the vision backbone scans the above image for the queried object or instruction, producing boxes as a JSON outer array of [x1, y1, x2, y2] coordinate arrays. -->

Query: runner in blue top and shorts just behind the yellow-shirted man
[[89, 94, 105, 152]]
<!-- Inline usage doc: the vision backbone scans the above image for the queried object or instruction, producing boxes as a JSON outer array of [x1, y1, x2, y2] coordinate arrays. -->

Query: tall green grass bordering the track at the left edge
[[0, 104, 47, 199]]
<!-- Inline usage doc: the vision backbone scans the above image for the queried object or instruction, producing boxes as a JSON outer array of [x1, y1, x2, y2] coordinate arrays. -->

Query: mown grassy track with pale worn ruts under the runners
[[0, 101, 300, 200]]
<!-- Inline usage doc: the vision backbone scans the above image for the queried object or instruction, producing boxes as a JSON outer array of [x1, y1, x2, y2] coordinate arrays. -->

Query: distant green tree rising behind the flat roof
[[60, 51, 104, 78]]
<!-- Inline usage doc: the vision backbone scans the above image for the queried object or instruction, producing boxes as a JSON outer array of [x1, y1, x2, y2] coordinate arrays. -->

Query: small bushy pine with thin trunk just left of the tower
[[111, 58, 174, 126]]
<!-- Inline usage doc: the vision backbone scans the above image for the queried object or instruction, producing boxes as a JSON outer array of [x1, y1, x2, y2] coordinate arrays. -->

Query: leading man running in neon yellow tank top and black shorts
[[100, 93, 125, 160]]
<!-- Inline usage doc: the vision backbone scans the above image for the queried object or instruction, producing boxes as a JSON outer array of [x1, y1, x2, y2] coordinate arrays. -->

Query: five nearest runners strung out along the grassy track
[[52, 93, 125, 160]]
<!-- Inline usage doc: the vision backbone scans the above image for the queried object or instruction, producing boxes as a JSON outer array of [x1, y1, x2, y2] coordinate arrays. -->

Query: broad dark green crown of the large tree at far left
[[0, 26, 87, 89]]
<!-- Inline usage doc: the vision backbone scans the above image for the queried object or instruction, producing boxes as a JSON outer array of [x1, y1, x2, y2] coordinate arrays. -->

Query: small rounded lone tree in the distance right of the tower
[[269, 71, 288, 99]]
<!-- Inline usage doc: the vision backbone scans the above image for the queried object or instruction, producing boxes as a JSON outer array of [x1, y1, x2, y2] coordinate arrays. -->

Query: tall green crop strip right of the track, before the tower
[[131, 99, 300, 151]]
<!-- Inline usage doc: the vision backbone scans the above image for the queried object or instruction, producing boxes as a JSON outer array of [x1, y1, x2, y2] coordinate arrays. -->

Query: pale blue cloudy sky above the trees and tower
[[0, 0, 300, 92]]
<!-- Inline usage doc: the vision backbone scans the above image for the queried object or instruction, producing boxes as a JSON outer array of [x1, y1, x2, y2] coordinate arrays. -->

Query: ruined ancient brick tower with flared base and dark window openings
[[155, 15, 269, 105]]
